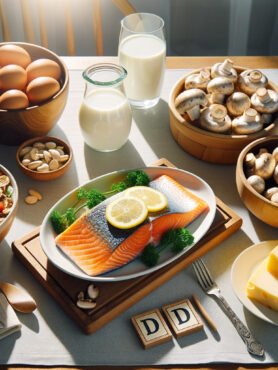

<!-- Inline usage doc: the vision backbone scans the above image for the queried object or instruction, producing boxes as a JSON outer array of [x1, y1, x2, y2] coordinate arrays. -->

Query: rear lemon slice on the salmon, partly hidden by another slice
[[125, 186, 168, 212]]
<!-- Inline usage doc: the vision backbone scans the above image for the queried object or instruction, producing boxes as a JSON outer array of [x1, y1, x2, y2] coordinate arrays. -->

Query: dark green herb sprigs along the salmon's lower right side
[[141, 228, 194, 267]]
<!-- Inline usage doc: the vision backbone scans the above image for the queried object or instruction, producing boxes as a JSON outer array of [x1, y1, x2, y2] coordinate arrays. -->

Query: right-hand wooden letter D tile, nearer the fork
[[162, 299, 203, 337]]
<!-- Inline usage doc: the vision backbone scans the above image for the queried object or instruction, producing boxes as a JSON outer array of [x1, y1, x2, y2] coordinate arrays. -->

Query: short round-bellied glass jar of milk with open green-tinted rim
[[79, 63, 132, 152]]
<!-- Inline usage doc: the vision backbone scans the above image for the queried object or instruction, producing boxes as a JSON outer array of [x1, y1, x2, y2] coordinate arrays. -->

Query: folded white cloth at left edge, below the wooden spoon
[[0, 292, 21, 340]]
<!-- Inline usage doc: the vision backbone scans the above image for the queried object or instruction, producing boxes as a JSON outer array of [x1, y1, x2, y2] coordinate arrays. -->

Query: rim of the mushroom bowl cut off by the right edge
[[236, 135, 278, 210]]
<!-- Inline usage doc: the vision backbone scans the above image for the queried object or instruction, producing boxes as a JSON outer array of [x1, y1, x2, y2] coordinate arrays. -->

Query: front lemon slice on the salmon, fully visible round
[[106, 196, 148, 229]]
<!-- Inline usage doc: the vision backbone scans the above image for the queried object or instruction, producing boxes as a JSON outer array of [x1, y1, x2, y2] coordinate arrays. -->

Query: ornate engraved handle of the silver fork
[[216, 294, 264, 357]]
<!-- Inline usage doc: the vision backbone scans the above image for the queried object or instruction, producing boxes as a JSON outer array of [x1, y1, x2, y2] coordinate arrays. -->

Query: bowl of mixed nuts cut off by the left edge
[[0, 165, 18, 242]]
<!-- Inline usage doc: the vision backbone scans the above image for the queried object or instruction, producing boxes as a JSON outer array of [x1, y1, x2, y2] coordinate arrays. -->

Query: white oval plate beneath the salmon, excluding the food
[[40, 167, 216, 282]]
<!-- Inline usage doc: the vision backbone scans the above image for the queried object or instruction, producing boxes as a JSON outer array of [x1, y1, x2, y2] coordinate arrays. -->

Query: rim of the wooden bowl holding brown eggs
[[0, 41, 69, 113]]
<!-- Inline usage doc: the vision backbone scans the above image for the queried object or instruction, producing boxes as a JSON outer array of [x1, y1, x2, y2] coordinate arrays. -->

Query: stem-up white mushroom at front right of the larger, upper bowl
[[232, 108, 263, 135]]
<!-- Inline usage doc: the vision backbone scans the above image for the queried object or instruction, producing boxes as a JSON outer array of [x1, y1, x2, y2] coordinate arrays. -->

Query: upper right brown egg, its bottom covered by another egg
[[26, 59, 62, 82]]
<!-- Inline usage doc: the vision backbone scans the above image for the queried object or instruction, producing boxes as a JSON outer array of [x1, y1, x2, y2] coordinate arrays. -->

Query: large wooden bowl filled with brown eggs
[[0, 42, 69, 145]]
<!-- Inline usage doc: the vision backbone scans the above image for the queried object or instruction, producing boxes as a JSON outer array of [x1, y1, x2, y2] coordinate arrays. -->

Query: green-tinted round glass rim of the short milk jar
[[82, 63, 127, 86]]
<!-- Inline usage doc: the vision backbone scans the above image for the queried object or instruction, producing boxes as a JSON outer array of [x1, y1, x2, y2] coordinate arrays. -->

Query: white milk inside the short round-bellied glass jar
[[79, 88, 132, 151]]
